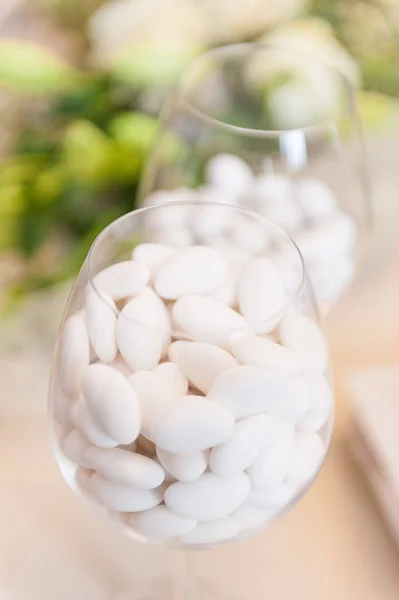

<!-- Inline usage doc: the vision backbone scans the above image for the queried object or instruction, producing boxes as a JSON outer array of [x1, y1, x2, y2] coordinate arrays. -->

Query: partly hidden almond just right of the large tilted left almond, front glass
[[129, 371, 177, 442]]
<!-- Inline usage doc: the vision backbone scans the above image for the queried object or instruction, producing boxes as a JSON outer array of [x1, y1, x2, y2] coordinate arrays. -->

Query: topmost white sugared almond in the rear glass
[[205, 154, 254, 197]]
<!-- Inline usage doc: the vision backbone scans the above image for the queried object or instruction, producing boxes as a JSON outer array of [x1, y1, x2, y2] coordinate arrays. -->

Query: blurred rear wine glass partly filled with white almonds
[[140, 42, 371, 311]]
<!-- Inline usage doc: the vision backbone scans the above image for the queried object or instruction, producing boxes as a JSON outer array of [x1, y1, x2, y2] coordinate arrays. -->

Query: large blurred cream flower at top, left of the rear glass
[[89, 0, 208, 84]]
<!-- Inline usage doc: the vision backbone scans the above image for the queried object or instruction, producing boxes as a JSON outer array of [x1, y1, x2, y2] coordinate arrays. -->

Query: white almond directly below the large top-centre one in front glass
[[173, 294, 248, 350]]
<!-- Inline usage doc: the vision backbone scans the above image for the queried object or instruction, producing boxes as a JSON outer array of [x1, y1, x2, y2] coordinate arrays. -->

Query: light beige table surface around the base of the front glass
[[0, 134, 399, 600]]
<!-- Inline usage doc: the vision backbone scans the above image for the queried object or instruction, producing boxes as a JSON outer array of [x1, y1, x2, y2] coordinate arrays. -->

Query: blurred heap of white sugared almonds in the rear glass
[[145, 154, 358, 307]]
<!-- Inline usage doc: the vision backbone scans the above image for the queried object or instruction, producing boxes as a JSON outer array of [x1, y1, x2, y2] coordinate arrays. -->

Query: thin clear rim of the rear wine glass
[[177, 40, 356, 138]]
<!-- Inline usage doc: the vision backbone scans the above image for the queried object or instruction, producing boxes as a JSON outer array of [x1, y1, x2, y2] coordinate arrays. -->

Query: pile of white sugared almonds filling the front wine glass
[[52, 243, 332, 546]]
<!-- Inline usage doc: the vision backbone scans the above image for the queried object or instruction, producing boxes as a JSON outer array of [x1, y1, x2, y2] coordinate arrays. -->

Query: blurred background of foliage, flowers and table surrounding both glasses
[[0, 0, 399, 600]]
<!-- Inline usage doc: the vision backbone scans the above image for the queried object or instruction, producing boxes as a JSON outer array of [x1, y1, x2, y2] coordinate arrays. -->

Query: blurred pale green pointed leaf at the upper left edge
[[0, 38, 78, 94]]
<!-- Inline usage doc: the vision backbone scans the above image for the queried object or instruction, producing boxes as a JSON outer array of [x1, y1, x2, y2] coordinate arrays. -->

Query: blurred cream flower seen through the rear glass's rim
[[247, 19, 360, 129]]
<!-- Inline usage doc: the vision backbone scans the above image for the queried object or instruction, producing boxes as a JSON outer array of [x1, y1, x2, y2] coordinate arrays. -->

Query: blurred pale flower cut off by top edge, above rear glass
[[200, 0, 305, 42]]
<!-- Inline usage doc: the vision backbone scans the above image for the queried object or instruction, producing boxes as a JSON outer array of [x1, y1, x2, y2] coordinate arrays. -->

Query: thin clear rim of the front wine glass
[[86, 199, 312, 333]]
